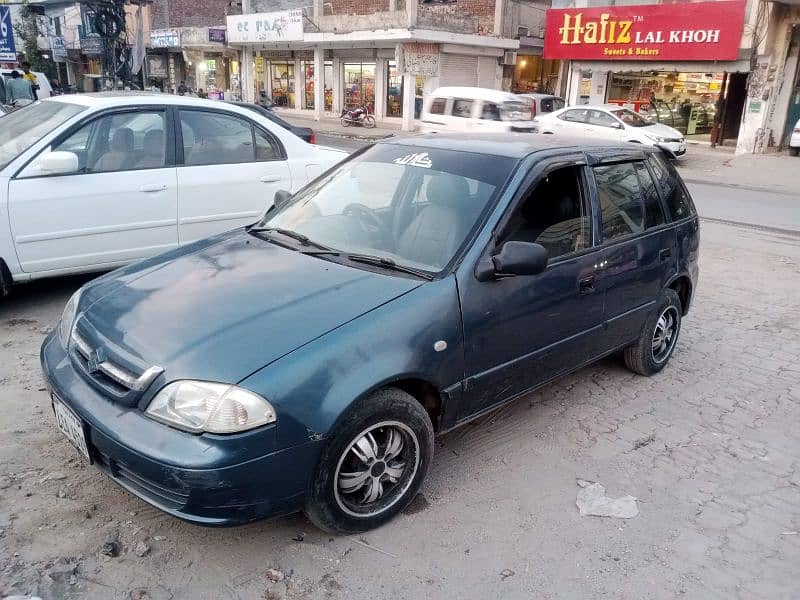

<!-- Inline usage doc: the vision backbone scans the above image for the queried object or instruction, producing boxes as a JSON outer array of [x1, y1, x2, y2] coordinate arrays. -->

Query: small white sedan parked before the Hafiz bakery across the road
[[534, 105, 686, 156]]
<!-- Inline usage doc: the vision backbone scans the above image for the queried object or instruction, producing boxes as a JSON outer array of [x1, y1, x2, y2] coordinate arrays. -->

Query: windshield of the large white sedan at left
[[0, 102, 86, 169]]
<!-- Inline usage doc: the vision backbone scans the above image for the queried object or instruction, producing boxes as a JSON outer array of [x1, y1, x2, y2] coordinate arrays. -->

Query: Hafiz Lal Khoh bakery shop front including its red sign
[[544, 0, 750, 142]]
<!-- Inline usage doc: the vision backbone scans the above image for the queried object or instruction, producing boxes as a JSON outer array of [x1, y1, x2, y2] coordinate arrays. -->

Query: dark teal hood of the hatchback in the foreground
[[81, 230, 421, 382]]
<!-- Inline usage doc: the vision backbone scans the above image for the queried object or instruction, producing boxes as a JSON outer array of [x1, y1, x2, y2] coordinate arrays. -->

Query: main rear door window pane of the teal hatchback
[[594, 163, 645, 242]]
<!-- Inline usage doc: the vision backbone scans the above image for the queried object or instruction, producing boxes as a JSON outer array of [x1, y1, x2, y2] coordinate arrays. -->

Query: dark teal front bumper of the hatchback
[[40, 332, 321, 526]]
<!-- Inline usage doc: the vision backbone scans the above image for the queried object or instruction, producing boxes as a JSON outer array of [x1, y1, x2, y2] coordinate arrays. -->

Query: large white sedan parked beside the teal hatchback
[[0, 92, 346, 296]]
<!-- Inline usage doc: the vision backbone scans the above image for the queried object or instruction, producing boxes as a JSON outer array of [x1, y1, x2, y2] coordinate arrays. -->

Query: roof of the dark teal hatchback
[[378, 133, 647, 159]]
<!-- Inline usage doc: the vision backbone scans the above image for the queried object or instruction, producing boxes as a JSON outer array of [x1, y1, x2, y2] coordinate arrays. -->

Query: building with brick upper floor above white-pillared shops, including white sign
[[227, 0, 519, 129]]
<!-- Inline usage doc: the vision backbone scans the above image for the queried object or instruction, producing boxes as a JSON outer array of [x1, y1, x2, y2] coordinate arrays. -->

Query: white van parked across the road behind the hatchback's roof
[[420, 87, 533, 133]]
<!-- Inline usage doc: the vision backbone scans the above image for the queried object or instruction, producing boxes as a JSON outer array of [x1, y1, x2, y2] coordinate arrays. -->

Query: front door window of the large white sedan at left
[[53, 111, 167, 173]]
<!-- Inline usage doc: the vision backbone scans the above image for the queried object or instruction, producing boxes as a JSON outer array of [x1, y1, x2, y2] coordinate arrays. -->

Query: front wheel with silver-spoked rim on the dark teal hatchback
[[305, 388, 433, 533]]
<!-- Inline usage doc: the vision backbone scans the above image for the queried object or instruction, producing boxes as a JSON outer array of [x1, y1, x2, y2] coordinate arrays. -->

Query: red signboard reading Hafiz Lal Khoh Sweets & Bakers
[[544, 0, 746, 61]]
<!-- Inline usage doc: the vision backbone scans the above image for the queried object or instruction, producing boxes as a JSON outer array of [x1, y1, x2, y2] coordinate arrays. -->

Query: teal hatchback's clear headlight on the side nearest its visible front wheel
[[145, 380, 275, 433]]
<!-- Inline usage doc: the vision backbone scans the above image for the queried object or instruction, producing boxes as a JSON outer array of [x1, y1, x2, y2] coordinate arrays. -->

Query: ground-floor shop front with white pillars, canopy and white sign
[[227, 10, 518, 129]]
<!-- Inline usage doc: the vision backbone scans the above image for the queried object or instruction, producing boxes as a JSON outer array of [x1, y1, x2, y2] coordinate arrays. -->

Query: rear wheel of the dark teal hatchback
[[624, 289, 682, 376]]
